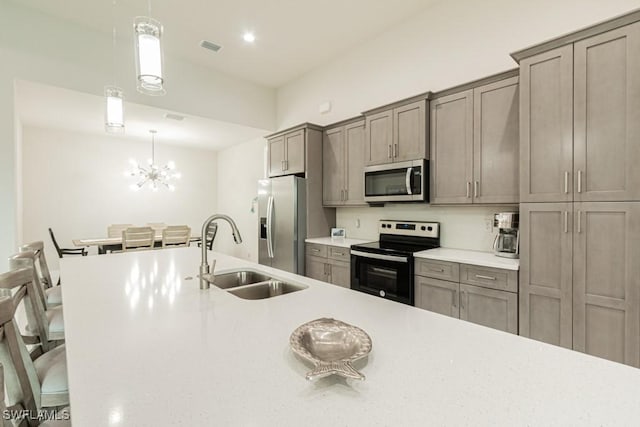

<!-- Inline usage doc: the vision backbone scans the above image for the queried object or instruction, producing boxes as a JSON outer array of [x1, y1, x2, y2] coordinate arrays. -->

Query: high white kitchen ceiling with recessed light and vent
[[13, 0, 438, 87]]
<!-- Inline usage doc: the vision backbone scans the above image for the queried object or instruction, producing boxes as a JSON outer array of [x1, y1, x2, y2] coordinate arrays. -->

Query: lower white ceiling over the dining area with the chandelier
[[16, 81, 267, 150]]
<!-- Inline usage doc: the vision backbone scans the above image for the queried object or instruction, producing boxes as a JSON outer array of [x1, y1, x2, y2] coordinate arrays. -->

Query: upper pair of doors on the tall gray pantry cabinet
[[520, 23, 640, 202]]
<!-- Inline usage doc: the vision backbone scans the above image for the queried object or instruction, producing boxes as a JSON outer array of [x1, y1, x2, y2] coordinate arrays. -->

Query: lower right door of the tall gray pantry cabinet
[[573, 202, 640, 367]]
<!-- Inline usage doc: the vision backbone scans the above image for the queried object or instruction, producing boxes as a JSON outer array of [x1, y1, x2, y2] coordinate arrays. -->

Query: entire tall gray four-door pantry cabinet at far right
[[513, 16, 640, 366]]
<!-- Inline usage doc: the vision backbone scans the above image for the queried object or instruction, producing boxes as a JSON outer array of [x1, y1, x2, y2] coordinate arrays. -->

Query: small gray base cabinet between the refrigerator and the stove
[[305, 243, 351, 288]]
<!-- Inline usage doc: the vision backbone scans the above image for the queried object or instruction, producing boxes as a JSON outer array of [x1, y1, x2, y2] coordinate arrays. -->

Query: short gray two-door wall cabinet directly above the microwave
[[365, 99, 428, 166]]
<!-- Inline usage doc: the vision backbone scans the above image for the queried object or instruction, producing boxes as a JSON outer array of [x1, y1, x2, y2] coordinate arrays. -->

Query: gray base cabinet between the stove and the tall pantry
[[415, 259, 518, 334]]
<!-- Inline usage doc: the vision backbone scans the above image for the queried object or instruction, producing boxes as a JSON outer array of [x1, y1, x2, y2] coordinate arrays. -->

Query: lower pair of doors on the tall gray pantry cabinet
[[520, 202, 640, 366]]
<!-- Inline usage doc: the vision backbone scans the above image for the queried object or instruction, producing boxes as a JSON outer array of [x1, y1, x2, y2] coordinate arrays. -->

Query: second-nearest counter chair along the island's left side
[[9, 251, 65, 353]]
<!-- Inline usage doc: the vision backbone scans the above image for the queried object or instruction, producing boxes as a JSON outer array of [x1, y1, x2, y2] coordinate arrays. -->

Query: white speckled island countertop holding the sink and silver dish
[[60, 248, 640, 427]]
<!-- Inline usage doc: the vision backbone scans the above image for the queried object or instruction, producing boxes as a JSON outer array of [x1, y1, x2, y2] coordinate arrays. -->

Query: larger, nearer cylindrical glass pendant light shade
[[133, 16, 166, 95]]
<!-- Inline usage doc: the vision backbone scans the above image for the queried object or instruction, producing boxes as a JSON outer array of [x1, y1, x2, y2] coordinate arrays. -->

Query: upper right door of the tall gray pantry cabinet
[[574, 23, 640, 201]]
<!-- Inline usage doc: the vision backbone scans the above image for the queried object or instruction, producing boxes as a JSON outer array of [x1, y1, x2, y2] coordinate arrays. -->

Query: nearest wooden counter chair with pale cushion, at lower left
[[0, 268, 69, 425]]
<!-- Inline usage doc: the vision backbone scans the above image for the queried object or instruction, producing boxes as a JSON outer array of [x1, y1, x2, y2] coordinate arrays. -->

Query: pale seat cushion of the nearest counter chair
[[33, 344, 69, 407]]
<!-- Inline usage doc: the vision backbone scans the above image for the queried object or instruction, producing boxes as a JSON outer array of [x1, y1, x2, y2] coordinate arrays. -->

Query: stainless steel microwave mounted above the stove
[[364, 159, 429, 204]]
